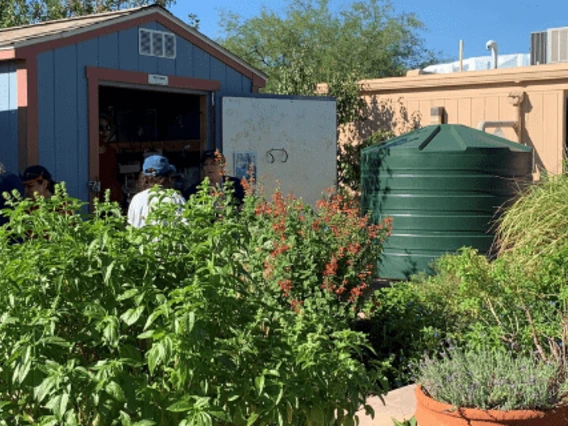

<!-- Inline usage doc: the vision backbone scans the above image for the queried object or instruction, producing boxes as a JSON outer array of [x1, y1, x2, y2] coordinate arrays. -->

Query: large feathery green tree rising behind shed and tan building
[[220, 0, 440, 93]]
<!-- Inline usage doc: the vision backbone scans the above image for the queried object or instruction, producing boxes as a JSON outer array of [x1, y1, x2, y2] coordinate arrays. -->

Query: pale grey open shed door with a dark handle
[[222, 97, 337, 205]]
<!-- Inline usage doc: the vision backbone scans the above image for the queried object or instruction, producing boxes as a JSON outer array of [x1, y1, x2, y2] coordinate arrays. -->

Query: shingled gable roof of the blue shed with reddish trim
[[0, 5, 268, 80]]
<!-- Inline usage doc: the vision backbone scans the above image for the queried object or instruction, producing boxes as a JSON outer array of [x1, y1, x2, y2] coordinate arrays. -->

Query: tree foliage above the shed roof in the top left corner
[[0, 0, 175, 28]]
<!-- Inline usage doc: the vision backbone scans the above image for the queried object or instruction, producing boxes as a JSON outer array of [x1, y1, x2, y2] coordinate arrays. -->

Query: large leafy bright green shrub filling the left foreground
[[0, 188, 388, 426]]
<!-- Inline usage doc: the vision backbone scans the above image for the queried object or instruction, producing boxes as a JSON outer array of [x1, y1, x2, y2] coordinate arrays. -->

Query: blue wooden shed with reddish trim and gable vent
[[0, 5, 267, 200]]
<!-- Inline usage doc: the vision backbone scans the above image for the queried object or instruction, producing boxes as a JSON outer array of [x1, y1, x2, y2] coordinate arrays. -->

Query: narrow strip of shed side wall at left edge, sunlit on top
[[0, 62, 18, 173]]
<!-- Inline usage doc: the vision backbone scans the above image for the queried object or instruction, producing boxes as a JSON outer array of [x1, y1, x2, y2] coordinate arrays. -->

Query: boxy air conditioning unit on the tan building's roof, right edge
[[531, 27, 568, 65]]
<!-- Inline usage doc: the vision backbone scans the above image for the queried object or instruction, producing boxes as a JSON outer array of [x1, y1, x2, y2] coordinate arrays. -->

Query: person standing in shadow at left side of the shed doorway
[[99, 114, 122, 203]]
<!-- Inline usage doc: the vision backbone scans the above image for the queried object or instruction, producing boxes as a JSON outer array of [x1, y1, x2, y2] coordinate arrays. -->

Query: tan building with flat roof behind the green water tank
[[340, 63, 568, 173]]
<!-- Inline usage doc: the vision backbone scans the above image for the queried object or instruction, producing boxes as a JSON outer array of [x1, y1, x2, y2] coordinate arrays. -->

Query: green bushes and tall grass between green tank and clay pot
[[370, 171, 568, 386]]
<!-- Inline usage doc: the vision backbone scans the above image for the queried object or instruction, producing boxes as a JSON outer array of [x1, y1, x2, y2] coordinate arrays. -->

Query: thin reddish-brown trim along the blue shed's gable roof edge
[[12, 7, 268, 80]]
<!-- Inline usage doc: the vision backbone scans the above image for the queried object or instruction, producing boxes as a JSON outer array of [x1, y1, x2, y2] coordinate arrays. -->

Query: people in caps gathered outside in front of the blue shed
[[0, 151, 245, 228]]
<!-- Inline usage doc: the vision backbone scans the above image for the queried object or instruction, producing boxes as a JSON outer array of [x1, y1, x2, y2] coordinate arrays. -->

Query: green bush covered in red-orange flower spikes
[[237, 184, 390, 322]]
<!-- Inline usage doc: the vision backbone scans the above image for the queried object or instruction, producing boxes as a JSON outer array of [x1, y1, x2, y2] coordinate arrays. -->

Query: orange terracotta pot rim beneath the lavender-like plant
[[415, 385, 568, 423]]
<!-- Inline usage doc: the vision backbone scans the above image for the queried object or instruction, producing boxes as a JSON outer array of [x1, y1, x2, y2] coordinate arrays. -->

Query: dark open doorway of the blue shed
[[99, 86, 207, 209]]
